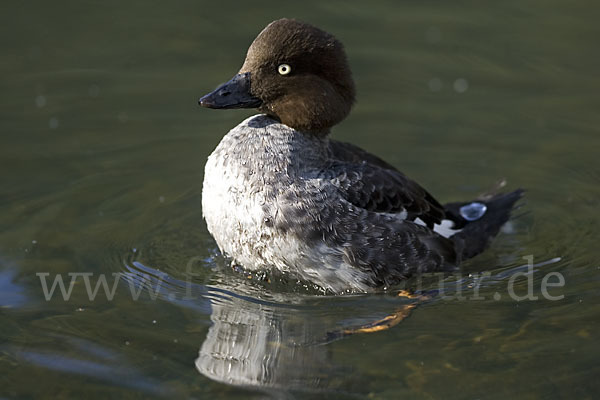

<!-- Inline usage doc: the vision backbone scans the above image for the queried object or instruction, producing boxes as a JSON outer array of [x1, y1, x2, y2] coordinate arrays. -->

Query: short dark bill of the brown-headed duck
[[198, 72, 262, 108]]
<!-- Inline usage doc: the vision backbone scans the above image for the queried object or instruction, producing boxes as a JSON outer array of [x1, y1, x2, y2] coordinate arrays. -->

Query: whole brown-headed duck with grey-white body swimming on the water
[[198, 18, 523, 294]]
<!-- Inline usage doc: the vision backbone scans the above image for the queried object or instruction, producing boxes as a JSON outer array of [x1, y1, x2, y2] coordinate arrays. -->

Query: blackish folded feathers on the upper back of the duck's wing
[[327, 140, 445, 228]]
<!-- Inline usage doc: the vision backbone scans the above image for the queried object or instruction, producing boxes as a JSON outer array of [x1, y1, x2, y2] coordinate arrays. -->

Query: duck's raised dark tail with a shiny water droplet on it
[[444, 189, 524, 260]]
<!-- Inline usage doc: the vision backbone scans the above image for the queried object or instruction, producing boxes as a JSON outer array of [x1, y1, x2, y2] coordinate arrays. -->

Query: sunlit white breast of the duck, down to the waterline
[[202, 116, 366, 292]]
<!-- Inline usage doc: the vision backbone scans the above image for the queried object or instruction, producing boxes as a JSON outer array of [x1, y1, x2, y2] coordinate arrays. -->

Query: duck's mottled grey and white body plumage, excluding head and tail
[[202, 115, 455, 293]]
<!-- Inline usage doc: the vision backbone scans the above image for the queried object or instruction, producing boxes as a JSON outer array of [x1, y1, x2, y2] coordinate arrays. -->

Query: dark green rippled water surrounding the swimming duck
[[0, 0, 600, 399]]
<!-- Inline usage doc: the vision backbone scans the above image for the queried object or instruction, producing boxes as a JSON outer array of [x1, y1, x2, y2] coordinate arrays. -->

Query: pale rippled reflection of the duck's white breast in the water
[[196, 290, 350, 396]]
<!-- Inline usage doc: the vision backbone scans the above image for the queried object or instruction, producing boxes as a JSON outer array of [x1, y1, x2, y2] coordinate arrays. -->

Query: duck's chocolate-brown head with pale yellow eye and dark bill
[[199, 19, 354, 134]]
